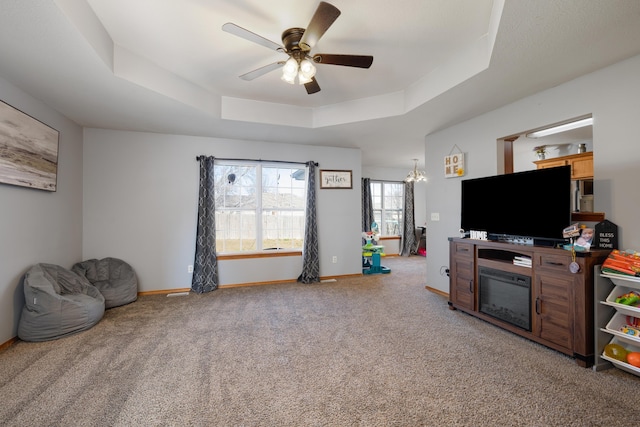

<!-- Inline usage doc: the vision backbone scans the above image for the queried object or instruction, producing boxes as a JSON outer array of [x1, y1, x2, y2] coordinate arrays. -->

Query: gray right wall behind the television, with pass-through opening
[[425, 56, 640, 292]]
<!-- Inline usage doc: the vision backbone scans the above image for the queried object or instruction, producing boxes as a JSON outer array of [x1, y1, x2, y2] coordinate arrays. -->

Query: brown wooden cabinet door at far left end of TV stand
[[449, 242, 476, 310]]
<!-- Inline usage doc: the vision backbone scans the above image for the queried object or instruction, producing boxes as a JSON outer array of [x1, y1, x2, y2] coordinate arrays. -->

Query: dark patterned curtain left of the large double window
[[191, 156, 218, 294]]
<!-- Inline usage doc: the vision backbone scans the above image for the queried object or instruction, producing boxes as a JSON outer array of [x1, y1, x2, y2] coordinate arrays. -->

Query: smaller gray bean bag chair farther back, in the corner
[[71, 258, 138, 308]]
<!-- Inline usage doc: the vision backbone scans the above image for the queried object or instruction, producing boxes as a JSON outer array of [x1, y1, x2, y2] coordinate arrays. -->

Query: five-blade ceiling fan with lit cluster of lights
[[222, 1, 373, 95]]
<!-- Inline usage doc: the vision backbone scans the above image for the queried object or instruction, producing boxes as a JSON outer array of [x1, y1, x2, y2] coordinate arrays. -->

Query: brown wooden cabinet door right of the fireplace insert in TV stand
[[532, 272, 574, 351]]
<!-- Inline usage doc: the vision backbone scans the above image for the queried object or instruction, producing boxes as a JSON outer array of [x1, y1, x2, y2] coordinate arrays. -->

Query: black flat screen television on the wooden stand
[[460, 166, 571, 246]]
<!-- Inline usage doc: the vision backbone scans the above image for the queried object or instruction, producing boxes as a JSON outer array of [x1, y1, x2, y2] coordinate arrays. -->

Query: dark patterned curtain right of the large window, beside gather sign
[[298, 162, 320, 283]]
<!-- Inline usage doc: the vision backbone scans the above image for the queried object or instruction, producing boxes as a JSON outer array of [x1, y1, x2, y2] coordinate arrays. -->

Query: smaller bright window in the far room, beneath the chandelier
[[371, 181, 404, 236]]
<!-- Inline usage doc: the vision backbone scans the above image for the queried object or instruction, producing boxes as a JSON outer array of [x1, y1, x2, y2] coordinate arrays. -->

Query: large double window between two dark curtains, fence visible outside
[[214, 162, 306, 253]]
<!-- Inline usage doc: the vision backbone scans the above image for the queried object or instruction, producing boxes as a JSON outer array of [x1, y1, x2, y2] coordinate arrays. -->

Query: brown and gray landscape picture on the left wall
[[0, 101, 60, 191]]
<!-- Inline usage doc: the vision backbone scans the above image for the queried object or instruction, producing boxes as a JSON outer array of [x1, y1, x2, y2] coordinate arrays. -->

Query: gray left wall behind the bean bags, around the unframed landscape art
[[0, 78, 82, 344]]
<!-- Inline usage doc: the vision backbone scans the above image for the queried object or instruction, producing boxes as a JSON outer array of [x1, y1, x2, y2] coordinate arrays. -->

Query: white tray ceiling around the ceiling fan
[[0, 0, 640, 168]]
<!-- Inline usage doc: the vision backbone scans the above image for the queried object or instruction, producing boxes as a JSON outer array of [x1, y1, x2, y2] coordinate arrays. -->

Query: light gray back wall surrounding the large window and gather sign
[[83, 129, 362, 291]]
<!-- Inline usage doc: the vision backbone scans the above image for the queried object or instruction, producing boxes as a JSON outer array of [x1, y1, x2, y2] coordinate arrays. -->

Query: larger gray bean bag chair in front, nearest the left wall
[[18, 264, 104, 341]]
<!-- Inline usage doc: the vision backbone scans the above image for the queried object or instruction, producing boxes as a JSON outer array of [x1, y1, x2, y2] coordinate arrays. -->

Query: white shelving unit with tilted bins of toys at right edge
[[593, 265, 640, 376]]
